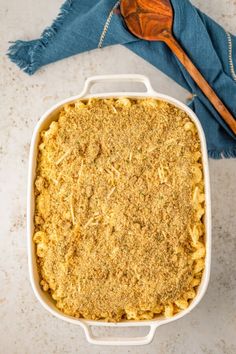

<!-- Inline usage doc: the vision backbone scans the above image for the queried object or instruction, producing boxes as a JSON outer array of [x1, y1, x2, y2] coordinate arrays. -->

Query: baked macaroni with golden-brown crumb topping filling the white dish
[[34, 98, 205, 321]]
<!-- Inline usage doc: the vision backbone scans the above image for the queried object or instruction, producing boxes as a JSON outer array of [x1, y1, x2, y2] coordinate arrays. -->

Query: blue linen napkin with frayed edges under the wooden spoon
[[8, 0, 236, 158]]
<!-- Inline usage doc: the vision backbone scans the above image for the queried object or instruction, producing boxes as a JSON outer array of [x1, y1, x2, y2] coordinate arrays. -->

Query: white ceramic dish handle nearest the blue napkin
[[81, 74, 155, 97]]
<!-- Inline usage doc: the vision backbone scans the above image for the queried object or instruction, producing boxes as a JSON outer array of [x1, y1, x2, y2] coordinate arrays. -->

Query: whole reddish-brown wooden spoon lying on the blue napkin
[[120, 0, 236, 134]]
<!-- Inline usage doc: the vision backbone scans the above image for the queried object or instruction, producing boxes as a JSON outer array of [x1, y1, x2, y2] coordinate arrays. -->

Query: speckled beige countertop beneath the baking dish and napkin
[[0, 0, 236, 354]]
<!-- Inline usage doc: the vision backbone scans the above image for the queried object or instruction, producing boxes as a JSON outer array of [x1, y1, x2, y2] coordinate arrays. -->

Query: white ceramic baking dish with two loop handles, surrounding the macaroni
[[27, 74, 211, 345]]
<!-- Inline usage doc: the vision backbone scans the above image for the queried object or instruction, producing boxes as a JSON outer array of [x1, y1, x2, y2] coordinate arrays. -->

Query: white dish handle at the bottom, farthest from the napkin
[[83, 323, 158, 346]]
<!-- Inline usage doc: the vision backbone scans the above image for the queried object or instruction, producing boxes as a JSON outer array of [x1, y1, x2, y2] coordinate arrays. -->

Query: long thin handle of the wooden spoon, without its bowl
[[163, 32, 236, 134]]
